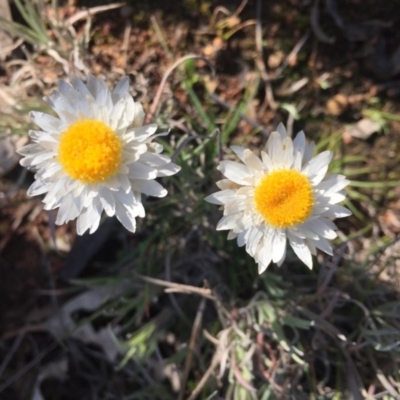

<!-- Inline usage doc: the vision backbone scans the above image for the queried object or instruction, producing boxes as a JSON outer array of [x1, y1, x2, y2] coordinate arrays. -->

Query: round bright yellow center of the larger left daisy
[[58, 119, 122, 183]]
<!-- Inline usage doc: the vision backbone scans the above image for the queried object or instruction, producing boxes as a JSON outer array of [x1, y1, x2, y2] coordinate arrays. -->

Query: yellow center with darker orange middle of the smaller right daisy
[[254, 169, 314, 228]]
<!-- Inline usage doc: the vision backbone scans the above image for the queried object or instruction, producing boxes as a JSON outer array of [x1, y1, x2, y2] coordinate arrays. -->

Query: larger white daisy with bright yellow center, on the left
[[19, 75, 180, 235]]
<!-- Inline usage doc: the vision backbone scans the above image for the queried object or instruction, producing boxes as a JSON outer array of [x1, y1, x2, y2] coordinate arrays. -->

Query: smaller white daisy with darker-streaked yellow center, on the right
[[206, 124, 351, 274]]
